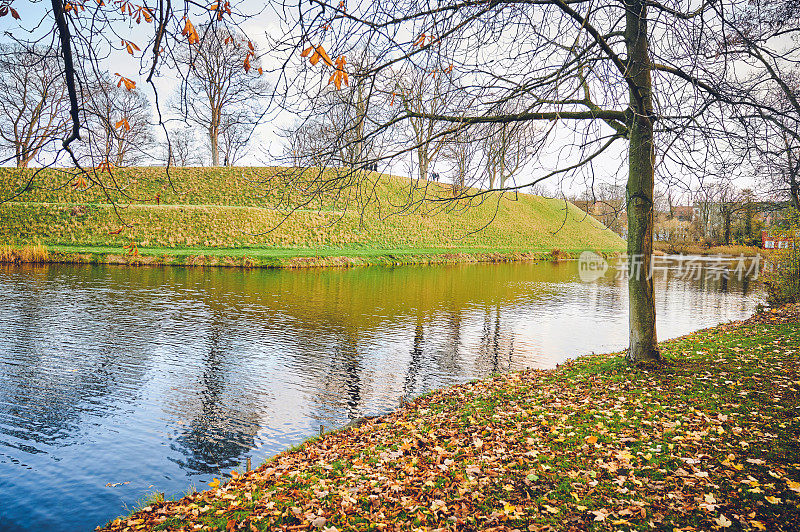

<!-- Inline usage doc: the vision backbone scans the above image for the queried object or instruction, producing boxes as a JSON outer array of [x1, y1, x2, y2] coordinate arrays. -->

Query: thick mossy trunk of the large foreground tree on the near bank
[[625, 0, 661, 363]]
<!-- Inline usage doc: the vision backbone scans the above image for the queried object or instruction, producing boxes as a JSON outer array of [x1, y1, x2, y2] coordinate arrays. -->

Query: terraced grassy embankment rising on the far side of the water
[[0, 168, 624, 266]]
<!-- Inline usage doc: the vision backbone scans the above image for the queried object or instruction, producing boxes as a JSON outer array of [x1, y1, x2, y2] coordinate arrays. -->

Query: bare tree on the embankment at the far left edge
[[0, 45, 69, 168]]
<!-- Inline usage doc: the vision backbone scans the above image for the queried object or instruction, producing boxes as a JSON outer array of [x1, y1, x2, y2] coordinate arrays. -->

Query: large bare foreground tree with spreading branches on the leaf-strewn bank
[[273, 0, 796, 362]]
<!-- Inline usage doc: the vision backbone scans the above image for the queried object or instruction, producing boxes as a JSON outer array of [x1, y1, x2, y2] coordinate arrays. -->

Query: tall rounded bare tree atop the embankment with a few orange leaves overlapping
[[175, 23, 268, 166]]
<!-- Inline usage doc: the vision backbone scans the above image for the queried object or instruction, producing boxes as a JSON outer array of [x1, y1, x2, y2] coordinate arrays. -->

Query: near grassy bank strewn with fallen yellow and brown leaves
[[100, 307, 800, 531]]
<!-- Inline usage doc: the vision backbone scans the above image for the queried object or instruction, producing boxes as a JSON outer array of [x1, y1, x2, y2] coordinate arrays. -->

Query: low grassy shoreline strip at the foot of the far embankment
[[0, 245, 621, 269]]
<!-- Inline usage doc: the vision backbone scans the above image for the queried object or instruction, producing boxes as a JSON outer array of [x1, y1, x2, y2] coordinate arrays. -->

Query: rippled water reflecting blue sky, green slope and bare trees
[[0, 262, 762, 531]]
